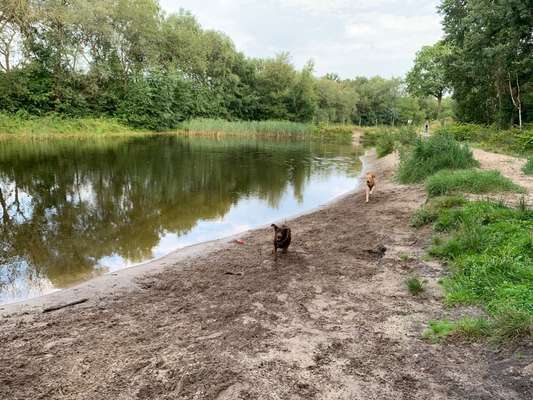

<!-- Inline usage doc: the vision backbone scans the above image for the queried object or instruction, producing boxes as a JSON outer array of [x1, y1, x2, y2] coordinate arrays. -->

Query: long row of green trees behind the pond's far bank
[[0, 0, 444, 130]]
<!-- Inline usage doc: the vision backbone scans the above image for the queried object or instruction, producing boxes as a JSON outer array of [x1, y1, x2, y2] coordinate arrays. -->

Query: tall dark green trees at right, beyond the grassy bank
[[407, 0, 533, 128]]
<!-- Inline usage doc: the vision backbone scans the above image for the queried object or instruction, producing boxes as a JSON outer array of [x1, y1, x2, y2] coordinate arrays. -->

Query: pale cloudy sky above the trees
[[160, 0, 442, 78]]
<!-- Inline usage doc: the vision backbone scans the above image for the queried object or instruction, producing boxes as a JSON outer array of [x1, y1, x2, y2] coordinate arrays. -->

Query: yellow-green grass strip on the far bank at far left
[[0, 113, 139, 136]]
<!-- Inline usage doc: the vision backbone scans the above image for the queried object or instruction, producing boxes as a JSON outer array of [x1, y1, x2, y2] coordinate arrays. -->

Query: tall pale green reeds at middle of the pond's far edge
[[180, 118, 316, 135]]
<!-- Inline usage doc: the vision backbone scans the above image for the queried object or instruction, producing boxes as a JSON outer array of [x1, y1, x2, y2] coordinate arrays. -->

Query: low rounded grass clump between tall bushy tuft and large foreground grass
[[426, 169, 524, 197]]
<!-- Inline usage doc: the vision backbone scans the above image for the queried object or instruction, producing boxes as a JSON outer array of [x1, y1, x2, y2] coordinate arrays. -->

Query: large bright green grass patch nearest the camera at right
[[426, 201, 533, 341]]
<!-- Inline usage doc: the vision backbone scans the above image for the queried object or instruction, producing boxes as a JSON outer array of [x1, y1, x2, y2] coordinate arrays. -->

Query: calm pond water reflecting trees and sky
[[0, 135, 359, 304]]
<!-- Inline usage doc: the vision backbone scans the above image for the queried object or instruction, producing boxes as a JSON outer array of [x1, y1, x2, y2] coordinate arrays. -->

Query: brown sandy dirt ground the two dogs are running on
[[0, 152, 533, 400]]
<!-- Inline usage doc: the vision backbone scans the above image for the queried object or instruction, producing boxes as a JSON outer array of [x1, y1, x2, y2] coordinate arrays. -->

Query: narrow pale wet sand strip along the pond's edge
[[0, 149, 376, 316]]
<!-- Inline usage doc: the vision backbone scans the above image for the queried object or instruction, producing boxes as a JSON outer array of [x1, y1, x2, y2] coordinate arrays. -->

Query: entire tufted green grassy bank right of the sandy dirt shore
[[374, 131, 533, 342]]
